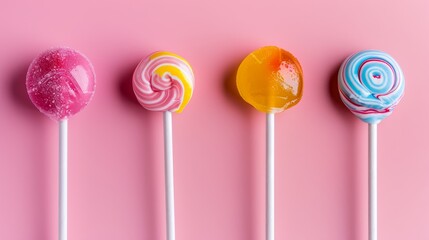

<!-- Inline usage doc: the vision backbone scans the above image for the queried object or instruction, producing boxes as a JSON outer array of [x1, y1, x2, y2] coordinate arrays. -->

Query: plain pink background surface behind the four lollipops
[[0, 0, 429, 240]]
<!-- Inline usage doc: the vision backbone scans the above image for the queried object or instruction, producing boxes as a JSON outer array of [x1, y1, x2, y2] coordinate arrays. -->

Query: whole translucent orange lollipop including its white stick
[[237, 46, 303, 240]]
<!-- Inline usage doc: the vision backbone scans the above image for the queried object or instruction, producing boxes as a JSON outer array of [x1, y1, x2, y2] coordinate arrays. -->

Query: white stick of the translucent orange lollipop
[[266, 113, 274, 240]]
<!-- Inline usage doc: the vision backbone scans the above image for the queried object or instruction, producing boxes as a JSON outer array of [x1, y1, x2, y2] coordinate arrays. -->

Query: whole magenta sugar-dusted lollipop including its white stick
[[27, 48, 95, 240]]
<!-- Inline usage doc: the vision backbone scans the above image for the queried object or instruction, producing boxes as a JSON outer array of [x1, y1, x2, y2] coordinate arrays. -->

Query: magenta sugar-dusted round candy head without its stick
[[26, 48, 95, 120]]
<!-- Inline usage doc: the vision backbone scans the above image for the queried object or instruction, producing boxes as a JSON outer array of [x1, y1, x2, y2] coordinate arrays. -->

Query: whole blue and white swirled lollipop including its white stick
[[338, 50, 405, 240]]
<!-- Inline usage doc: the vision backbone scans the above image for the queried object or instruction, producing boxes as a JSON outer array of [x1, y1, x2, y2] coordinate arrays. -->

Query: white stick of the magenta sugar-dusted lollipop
[[58, 119, 67, 240]]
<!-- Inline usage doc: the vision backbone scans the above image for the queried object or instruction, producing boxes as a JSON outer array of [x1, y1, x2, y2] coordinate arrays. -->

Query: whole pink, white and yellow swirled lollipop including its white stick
[[133, 52, 194, 240]]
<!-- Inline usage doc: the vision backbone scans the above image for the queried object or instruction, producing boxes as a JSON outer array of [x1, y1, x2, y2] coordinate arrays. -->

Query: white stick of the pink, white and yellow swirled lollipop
[[164, 111, 176, 240]]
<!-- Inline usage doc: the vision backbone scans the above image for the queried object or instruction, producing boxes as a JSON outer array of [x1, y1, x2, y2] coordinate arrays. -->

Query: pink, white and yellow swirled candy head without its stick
[[133, 52, 194, 112]]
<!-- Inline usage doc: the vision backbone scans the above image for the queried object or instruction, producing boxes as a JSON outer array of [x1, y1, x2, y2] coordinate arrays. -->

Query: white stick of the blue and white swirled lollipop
[[368, 123, 377, 240]]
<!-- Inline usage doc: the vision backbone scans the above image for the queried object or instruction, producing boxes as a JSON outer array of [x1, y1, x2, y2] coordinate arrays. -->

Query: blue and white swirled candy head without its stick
[[338, 50, 405, 123]]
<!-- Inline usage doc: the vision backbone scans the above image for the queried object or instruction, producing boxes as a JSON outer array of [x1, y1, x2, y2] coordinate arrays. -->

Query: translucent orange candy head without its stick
[[237, 46, 303, 113]]
